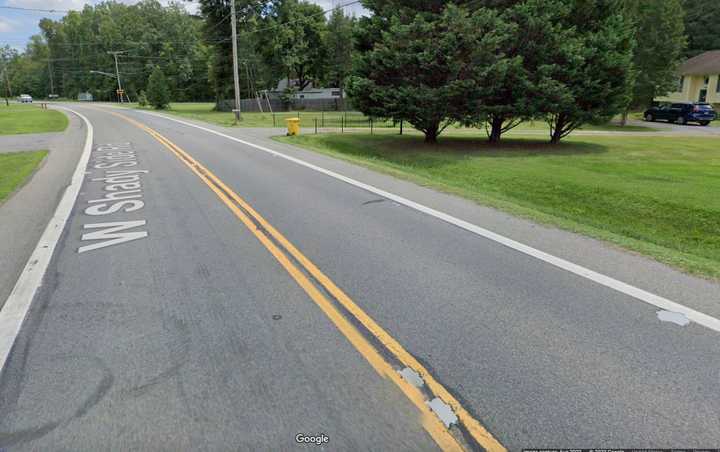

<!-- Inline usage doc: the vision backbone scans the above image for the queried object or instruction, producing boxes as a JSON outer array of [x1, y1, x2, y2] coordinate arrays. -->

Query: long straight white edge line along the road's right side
[[136, 110, 720, 332]]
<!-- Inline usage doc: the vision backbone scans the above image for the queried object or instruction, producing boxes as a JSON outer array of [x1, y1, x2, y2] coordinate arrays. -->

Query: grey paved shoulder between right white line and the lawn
[[132, 111, 720, 317]]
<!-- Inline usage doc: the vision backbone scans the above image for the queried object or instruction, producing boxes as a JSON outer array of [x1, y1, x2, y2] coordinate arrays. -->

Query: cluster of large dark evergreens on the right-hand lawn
[[348, 0, 686, 143]]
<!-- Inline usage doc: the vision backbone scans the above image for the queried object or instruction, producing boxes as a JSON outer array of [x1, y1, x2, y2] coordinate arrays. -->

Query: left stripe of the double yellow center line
[[112, 113, 462, 451]]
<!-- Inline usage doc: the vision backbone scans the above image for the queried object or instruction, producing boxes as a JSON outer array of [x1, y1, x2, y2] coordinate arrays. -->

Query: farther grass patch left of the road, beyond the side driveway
[[0, 104, 68, 135]]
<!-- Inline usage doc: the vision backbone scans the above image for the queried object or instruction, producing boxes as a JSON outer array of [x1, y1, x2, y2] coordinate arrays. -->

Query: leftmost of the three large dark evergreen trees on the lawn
[[348, 1, 510, 143]]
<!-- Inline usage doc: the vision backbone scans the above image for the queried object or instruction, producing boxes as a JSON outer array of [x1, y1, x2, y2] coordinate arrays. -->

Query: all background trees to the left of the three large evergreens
[[0, 0, 355, 105]]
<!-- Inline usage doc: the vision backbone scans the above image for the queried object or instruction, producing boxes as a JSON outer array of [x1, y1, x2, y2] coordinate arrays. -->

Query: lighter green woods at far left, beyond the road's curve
[[0, 0, 213, 100]]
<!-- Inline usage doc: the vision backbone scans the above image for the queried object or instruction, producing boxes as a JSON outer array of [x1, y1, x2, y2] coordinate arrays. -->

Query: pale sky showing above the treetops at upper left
[[0, 0, 363, 50]]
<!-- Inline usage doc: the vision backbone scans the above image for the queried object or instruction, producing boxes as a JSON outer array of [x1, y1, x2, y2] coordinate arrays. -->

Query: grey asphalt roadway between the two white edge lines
[[0, 105, 720, 451]]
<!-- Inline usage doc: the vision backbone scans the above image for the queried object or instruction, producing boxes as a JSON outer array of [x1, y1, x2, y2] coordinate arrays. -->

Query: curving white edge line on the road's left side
[[0, 107, 93, 372]]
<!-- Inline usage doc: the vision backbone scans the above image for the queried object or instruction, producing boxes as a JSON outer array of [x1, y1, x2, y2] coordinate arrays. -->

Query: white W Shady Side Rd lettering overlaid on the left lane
[[78, 143, 149, 253]]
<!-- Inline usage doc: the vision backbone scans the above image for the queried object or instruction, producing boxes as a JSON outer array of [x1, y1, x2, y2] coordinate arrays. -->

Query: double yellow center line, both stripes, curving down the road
[[110, 112, 506, 452]]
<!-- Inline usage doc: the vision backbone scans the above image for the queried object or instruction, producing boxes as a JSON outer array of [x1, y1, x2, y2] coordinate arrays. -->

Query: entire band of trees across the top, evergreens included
[[0, 0, 720, 142]]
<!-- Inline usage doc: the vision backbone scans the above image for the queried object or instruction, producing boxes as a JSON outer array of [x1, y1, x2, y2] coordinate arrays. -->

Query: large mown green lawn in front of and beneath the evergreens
[[277, 134, 720, 278]]
